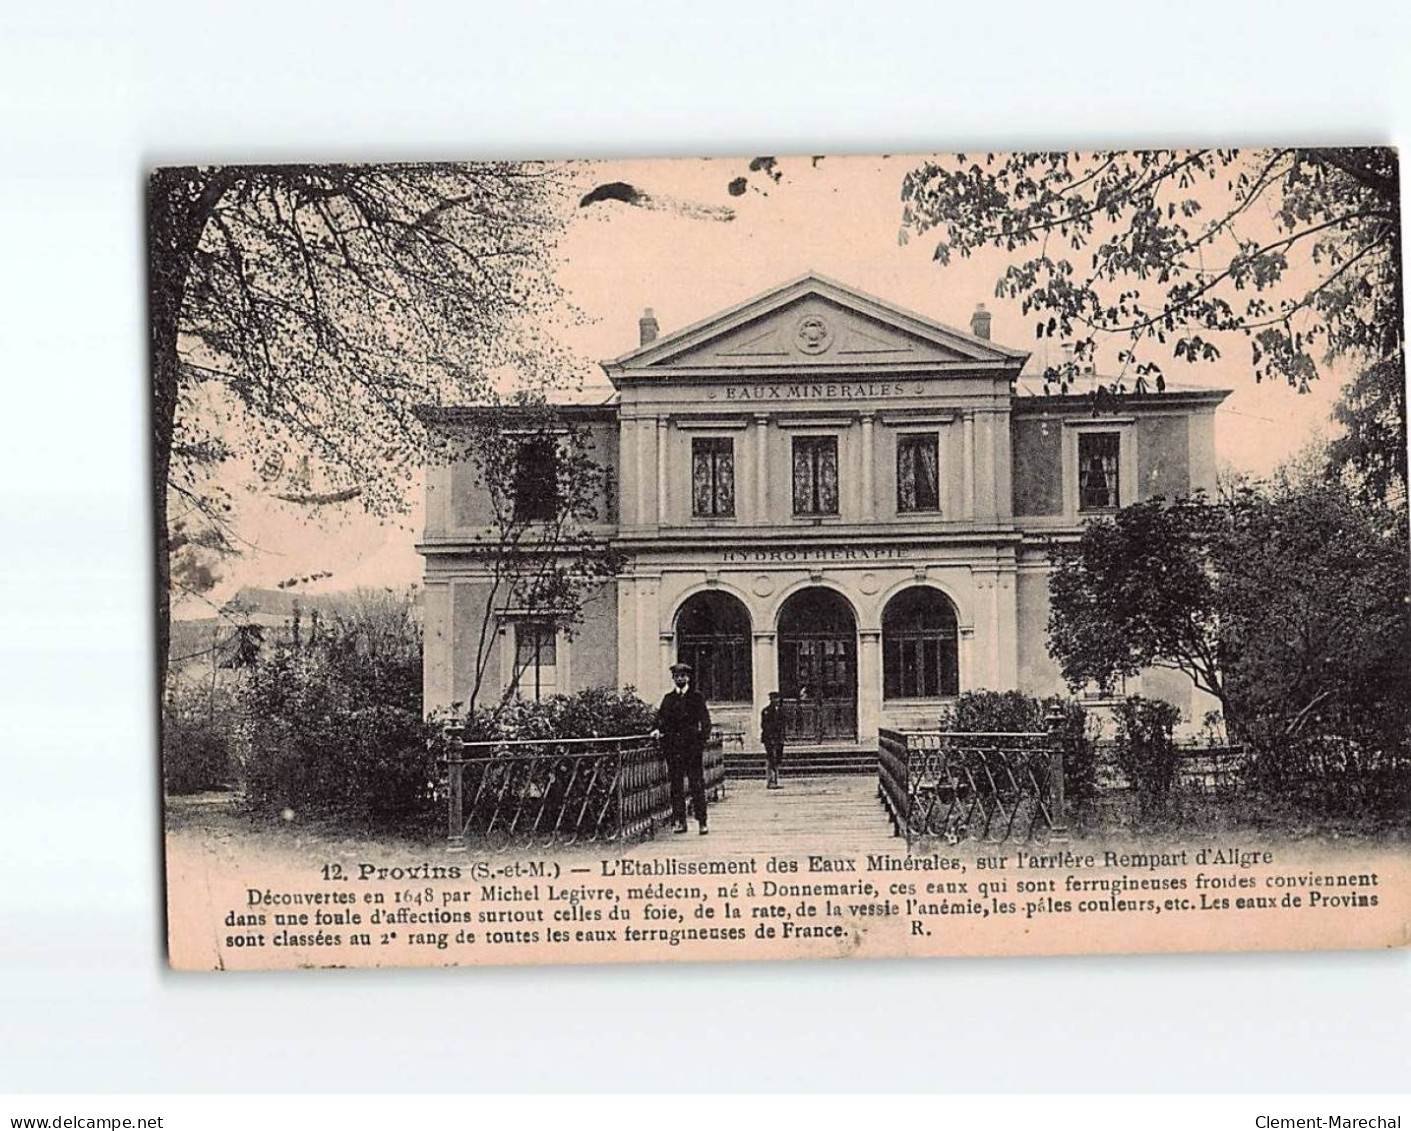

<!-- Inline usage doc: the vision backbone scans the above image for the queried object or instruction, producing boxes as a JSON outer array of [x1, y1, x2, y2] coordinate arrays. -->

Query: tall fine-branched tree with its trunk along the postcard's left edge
[[148, 162, 563, 691]]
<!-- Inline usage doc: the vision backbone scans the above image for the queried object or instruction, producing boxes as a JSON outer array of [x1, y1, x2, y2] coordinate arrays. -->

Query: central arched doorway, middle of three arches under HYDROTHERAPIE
[[779, 588, 858, 743]]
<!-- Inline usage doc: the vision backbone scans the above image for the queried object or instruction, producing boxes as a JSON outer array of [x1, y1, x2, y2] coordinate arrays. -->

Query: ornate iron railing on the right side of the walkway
[[878, 719, 1068, 848]]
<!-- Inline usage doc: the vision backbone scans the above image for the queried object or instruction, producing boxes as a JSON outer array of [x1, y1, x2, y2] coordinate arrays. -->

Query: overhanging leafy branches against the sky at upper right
[[902, 148, 1407, 498]]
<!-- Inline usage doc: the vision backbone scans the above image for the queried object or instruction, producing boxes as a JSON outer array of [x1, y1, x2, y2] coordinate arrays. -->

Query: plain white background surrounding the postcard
[[0, 0, 1411, 1092]]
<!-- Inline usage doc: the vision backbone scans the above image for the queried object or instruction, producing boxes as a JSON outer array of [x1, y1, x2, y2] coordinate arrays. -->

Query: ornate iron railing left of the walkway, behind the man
[[446, 730, 725, 848]]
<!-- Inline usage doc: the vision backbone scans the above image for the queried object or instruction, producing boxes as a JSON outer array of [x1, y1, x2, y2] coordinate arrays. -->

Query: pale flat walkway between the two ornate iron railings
[[626, 776, 906, 859]]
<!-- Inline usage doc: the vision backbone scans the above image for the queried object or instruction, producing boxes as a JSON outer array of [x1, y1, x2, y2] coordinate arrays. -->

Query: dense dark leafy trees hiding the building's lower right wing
[[1048, 481, 1411, 749]]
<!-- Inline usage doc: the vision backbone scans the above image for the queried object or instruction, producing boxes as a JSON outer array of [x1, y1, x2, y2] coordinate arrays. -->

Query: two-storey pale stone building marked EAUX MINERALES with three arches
[[419, 275, 1226, 749]]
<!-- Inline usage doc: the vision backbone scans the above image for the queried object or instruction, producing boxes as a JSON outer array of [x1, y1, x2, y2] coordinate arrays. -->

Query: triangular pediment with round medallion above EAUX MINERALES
[[604, 275, 1027, 378]]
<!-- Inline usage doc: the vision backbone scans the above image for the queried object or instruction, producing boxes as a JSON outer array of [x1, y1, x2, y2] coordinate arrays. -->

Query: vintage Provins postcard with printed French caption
[[148, 148, 1411, 970]]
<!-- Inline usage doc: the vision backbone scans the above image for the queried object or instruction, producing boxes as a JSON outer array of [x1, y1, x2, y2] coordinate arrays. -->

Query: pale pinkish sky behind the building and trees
[[176, 155, 1348, 618]]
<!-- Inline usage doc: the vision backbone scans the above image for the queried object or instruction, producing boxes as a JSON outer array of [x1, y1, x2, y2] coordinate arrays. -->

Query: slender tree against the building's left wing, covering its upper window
[[428, 395, 622, 715]]
